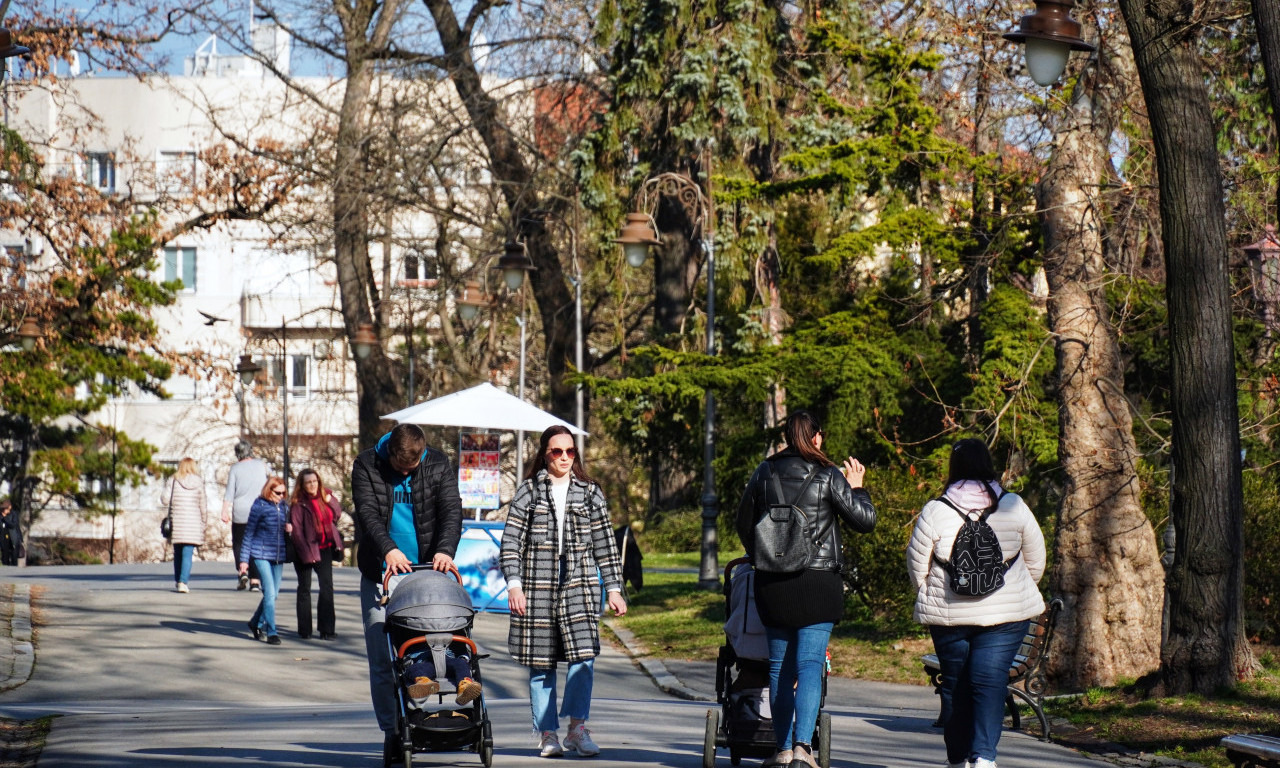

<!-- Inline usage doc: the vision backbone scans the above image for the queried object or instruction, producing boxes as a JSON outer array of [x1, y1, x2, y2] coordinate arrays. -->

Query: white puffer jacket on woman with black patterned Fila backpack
[[906, 481, 1044, 627]]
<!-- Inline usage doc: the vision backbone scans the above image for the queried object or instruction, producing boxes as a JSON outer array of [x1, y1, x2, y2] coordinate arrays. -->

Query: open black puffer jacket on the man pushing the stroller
[[351, 437, 462, 581]]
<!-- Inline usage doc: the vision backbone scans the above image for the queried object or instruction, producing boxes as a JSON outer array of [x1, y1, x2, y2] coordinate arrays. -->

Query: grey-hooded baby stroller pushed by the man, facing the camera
[[383, 566, 493, 768]]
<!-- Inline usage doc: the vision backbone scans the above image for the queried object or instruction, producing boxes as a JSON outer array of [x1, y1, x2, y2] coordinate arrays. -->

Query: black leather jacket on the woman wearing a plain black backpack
[[737, 448, 876, 571]]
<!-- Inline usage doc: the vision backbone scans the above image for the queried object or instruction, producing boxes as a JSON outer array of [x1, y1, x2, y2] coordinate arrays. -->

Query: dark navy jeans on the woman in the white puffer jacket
[[929, 620, 1030, 763]]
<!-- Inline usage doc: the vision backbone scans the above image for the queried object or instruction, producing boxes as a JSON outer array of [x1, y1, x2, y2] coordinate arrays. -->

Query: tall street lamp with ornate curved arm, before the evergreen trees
[[614, 173, 719, 589]]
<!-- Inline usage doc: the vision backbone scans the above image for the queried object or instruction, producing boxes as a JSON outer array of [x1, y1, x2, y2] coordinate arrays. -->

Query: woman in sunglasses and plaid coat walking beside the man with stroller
[[502, 426, 627, 758]]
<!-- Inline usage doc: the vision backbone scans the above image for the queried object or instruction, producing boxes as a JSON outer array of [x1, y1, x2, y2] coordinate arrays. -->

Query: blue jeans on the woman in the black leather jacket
[[764, 622, 833, 751]]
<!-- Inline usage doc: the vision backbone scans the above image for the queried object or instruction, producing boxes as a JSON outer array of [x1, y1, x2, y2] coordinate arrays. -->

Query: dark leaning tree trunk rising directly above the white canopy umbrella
[[424, 0, 576, 421]]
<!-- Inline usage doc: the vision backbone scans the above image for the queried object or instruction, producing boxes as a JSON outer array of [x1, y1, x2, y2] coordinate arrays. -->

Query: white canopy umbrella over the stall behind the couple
[[383, 381, 586, 435]]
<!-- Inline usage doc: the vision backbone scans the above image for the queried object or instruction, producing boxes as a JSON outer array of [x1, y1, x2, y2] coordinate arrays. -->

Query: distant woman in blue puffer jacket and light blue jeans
[[239, 477, 289, 645]]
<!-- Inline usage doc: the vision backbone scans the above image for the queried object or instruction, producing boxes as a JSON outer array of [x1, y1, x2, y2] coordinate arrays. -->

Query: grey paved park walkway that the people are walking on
[[0, 564, 1187, 768]]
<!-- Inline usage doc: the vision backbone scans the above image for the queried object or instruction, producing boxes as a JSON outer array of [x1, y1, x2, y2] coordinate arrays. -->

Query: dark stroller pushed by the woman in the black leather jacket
[[703, 557, 831, 768]]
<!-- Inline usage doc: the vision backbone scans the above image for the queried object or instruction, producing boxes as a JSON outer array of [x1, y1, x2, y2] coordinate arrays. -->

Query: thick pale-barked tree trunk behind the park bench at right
[[1037, 60, 1164, 690]]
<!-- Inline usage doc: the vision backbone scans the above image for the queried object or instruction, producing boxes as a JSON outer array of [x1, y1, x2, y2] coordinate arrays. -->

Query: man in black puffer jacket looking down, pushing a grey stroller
[[351, 424, 462, 765]]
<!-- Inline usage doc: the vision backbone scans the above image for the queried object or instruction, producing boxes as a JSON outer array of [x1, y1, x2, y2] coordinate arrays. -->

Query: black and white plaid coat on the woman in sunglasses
[[500, 470, 622, 669]]
